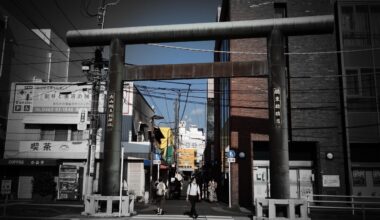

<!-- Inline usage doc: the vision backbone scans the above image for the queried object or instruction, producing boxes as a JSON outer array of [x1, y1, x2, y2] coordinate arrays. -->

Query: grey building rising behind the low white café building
[[0, 4, 72, 167]]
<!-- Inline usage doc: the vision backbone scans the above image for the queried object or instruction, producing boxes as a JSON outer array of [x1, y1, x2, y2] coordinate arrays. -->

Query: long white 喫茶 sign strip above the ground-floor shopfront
[[19, 141, 87, 153]]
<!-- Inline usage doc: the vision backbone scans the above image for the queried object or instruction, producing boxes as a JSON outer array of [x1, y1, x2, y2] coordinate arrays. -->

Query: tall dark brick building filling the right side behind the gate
[[210, 0, 380, 206]]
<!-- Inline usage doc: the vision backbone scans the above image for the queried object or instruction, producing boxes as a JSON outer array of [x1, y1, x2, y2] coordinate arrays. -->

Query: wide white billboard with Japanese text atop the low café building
[[13, 84, 104, 113]]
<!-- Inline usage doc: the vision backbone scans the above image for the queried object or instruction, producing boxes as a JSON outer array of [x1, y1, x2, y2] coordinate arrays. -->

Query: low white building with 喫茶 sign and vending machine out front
[[0, 82, 153, 199]]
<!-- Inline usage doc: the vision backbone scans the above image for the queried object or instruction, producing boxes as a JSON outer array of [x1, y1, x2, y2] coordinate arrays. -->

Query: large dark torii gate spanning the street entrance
[[67, 15, 334, 202]]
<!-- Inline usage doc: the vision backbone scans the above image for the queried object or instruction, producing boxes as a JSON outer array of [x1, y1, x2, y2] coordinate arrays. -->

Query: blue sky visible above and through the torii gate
[[1, 0, 221, 128]]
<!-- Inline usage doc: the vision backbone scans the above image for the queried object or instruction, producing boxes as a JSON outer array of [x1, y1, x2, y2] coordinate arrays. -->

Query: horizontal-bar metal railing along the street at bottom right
[[307, 194, 380, 216]]
